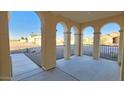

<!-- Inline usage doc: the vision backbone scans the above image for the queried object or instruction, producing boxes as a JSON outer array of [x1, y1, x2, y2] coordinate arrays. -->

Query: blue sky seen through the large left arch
[[9, 12, 42, 39]]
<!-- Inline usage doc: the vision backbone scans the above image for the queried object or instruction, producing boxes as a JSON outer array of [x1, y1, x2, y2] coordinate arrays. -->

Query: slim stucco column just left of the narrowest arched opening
[[64, 32, 71, 60]]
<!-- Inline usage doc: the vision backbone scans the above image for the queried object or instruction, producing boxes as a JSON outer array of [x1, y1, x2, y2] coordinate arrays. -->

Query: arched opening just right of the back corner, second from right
[[82, 26, 94, 56]]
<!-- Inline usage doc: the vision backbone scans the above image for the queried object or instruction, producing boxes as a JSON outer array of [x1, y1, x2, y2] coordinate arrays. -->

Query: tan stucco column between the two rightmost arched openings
[[93, 32, 100, 59]]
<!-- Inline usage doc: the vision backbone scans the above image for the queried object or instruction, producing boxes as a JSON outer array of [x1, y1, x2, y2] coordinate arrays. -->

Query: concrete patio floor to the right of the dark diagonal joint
[[57, 55, 120, 81]]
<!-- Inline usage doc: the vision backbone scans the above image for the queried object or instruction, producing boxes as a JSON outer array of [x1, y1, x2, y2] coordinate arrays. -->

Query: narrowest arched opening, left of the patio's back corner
[[70, 26, 78, 56]]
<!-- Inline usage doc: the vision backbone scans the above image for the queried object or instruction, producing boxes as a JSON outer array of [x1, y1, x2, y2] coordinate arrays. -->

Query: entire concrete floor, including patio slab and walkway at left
[[11, 53, 120, 81]]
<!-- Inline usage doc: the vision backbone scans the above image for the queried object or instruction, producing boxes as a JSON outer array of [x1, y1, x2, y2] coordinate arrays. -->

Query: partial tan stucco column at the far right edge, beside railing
[[118, 29, 123, 65]]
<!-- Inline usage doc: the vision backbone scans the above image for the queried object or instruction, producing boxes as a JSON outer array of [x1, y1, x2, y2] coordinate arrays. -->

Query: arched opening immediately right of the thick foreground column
[[56, 22, 66, 60]]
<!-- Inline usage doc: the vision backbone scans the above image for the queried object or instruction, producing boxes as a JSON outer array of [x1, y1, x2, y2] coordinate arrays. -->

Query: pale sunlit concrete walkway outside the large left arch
[[11, 53, 39, 77]]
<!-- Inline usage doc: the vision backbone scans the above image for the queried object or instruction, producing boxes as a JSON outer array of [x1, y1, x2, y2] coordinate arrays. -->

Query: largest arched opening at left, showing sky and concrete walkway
[[9, 11, 42, 77]]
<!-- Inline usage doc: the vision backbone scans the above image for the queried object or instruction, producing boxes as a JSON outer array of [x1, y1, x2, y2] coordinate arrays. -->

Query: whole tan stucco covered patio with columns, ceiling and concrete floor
[[0, 11, 124, 81]]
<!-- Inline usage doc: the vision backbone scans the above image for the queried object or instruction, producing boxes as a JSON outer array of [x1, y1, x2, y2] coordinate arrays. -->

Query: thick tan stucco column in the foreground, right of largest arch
[[41, 13, 56, 70]]
